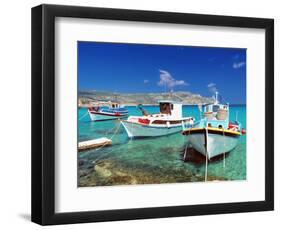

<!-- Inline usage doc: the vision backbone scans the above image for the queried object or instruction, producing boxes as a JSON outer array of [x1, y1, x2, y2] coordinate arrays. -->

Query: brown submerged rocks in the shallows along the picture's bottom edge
[[79, 157, 225, 186]]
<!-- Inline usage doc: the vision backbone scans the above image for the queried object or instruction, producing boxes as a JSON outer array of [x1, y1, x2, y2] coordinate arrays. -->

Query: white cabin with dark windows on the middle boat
[[159, 101, 182, 118]]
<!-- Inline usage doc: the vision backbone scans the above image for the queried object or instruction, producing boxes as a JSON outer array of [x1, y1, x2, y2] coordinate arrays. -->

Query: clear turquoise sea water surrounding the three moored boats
[[78, 105, 246, 186]]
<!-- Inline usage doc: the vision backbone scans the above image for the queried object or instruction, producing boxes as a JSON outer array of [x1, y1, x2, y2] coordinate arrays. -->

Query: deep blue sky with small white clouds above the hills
[[78, 41, 246, 104]]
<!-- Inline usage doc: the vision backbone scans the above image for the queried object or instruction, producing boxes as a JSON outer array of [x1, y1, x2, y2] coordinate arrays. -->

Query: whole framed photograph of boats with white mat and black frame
[[32, 5, 274, 225]]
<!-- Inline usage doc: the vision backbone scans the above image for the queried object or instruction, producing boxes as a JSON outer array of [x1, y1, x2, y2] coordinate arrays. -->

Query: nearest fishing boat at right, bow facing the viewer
[[182, 92, 246, 159]]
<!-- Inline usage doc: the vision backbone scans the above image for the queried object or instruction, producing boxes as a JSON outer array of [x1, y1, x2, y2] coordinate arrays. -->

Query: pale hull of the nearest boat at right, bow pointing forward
[[184, 129, 240, 159]]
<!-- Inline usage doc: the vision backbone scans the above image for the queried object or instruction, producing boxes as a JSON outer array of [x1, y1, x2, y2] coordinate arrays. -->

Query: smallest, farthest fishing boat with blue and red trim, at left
[[88, 101, 128, 121]]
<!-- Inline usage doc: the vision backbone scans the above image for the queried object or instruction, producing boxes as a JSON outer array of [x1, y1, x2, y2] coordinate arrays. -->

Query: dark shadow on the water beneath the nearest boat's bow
[[181, 148, 229, 165]]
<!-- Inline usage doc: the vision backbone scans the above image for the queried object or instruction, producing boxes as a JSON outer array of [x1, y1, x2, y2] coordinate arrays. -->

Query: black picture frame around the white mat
[[31, 5, 274, 225]]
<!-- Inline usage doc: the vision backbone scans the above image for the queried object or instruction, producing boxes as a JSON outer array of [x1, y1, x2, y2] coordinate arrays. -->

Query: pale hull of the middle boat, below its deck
[[121, 121, 182, 138]]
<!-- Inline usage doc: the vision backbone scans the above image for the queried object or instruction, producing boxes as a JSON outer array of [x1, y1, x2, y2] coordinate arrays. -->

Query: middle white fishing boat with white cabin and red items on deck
[[121, 100, 194, 138]]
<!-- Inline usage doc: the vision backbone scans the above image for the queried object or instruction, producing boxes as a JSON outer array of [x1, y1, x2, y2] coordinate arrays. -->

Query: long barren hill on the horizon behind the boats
[[78, 90, 213, 105]]
